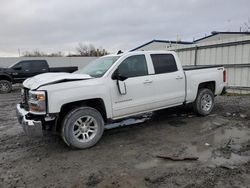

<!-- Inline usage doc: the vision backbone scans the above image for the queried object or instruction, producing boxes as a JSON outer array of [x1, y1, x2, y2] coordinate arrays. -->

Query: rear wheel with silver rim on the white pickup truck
[[193, 88, 214, 116]]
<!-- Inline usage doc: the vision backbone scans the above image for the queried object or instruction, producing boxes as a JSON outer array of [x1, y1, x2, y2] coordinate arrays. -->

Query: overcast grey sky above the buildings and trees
[[0, 0, 250, 57]]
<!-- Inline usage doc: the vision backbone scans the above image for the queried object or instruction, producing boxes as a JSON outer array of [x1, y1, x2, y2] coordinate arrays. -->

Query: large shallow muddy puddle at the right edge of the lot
[[186, 127, 250, 165]]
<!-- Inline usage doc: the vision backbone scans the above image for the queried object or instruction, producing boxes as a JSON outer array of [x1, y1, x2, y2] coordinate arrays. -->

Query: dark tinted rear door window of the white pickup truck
[[151, 54, 177, 74]]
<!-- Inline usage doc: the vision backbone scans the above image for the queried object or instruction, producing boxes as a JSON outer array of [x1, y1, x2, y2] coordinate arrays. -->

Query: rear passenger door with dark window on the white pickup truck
[[150, 53, 185, 108]]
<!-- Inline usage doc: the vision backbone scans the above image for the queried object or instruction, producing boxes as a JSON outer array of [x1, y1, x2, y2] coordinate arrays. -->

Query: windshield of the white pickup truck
[[75, 56, 120, 77]]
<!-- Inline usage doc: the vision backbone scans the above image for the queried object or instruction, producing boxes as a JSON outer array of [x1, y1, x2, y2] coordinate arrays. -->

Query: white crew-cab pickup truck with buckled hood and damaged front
[[17, 51, 226, 149]]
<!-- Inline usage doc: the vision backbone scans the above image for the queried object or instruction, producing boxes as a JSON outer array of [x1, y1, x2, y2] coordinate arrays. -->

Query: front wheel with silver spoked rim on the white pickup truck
[[61, 107, 104, 149]]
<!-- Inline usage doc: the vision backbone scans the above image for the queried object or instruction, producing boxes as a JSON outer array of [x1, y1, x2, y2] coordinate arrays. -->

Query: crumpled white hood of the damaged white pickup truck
[[23, 73, 92, 90]]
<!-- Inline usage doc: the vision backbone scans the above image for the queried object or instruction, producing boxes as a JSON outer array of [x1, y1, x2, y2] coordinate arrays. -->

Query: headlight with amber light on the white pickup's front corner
[[28, 91, 46, 114]]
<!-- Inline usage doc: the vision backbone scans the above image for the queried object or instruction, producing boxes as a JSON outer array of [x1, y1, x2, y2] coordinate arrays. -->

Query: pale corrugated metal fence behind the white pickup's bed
[[170, 36, 250, 94]]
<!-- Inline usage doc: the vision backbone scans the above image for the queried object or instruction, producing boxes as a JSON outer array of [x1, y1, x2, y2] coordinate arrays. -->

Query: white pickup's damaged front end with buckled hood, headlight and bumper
[[16, 73, 92, 136]]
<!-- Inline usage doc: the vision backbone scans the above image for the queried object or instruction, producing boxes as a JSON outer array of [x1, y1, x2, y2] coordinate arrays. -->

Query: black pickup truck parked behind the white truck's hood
[[0, 60, 78, 93]]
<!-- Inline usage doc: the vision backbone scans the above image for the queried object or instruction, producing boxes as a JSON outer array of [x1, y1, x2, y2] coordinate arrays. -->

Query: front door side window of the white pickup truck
[[118, 55, 148, 77]]
